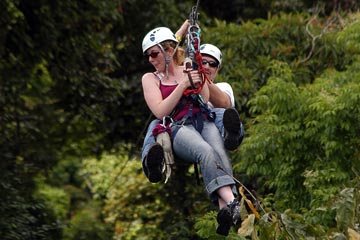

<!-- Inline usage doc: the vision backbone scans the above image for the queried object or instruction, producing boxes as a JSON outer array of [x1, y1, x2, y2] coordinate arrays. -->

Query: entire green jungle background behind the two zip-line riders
[[0, 0, 360, 240]]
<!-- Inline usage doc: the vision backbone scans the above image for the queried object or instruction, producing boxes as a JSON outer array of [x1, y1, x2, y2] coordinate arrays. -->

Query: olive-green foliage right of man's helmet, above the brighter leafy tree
[[202, 13, 354, 118]]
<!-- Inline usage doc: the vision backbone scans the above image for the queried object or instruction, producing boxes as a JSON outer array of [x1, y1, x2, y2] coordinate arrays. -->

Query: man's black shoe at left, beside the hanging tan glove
[[143, 143, 164, 183]]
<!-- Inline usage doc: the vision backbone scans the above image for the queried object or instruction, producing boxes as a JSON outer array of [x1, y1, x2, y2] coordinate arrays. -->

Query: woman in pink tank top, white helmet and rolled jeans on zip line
[[142, 27, 240, 235]]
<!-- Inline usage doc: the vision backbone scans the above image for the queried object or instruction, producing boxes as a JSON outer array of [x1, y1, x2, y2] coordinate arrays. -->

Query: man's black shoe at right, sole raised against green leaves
[[223, 108, 241, 151]]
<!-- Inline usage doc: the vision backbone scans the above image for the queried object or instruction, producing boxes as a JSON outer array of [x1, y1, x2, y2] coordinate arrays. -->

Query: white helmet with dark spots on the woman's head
[[142, 27, 179, 53]]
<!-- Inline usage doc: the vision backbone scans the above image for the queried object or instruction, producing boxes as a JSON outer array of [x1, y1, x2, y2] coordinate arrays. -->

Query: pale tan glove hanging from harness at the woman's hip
[[156, 131, 175, 183]]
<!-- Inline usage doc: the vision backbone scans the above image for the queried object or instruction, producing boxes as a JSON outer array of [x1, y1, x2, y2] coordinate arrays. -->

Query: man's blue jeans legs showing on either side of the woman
[[141, 108, 225, 160]]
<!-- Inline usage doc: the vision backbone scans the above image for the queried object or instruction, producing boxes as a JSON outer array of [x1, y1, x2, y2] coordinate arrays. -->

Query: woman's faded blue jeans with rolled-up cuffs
[[171, 121, 237, 203]]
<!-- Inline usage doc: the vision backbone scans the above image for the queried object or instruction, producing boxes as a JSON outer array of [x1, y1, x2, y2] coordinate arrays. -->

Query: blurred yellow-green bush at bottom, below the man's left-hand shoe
[[82, 151, 210, 239]]
